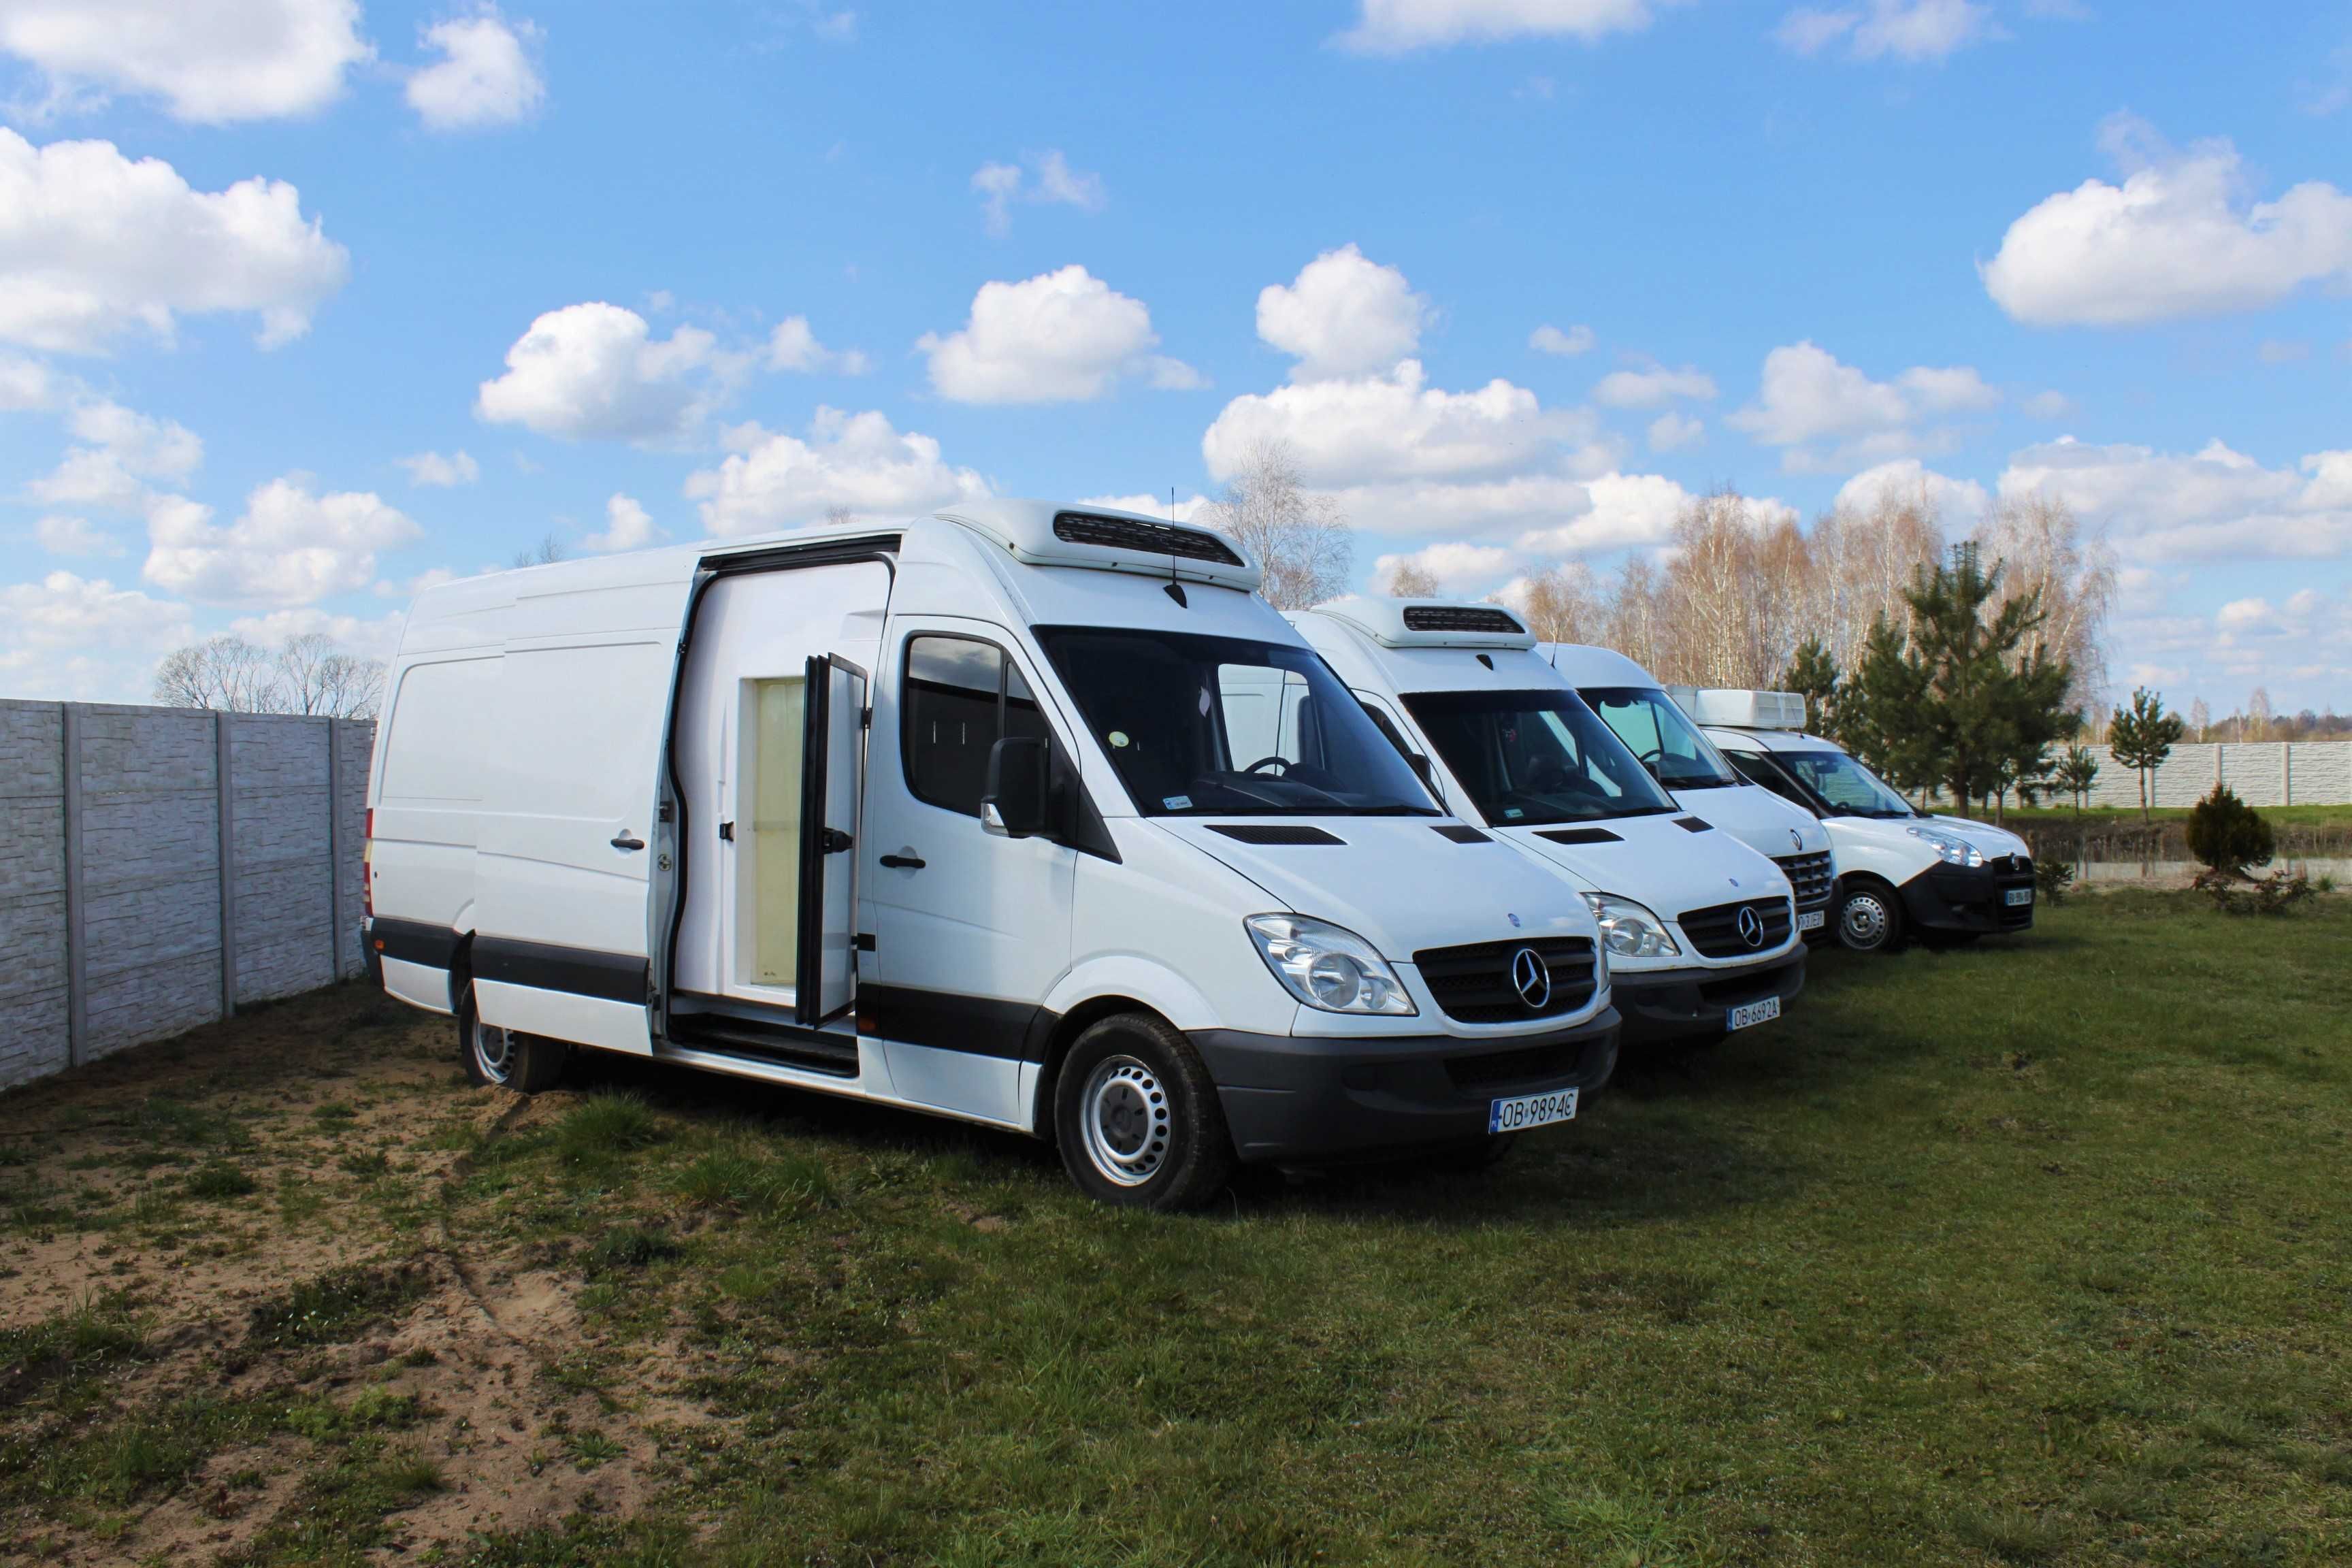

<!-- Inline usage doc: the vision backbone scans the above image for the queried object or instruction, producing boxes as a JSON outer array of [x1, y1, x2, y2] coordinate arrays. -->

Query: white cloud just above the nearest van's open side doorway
[[687, 409, 990, 534]]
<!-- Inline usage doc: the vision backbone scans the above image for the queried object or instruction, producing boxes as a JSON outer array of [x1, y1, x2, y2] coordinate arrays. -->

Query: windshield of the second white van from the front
[[1404, 691, 1682, 828]]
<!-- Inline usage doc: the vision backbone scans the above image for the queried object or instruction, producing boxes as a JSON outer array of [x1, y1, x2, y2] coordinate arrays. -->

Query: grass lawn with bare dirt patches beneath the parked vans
[[0, 894, 2352, 1568]]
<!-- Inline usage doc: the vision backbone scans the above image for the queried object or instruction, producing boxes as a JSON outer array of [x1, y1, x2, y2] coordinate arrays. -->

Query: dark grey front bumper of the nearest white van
[[1190, 1009, 1618, 1161]]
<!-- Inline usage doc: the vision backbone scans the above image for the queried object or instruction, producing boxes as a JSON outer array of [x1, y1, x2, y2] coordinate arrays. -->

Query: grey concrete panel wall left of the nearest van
[[0, 700, 376, 1086]]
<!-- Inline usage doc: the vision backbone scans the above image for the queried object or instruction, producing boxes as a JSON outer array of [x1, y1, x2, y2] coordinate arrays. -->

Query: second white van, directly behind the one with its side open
[[1291, 600, 1804, 1039]]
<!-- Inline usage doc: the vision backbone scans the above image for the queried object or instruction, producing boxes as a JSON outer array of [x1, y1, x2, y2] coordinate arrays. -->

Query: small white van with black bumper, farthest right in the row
[[1675, 689, 2034, 952]]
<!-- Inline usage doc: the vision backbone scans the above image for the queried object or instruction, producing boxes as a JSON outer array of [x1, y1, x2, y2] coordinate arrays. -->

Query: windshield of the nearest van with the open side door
[[1037, 625, 1439, 816]]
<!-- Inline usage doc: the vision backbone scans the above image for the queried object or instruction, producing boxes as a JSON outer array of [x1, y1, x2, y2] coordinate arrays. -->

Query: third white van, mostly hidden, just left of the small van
[[1536, 642, 1837, 941]]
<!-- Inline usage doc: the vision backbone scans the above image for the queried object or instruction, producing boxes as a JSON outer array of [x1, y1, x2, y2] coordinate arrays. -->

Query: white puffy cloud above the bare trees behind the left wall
[[146, 475, 419, 606]]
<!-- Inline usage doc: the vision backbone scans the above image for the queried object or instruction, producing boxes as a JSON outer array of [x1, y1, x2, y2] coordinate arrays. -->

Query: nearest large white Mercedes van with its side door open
[[365, 501, 1618, 1208]]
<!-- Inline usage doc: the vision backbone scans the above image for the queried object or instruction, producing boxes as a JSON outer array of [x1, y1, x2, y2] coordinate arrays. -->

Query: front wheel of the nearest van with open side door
[[1054, 1013, 1235, 1208]]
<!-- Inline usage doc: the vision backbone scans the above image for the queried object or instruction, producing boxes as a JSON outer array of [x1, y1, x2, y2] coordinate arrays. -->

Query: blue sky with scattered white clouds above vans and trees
[[0, 0, 2352, 713]]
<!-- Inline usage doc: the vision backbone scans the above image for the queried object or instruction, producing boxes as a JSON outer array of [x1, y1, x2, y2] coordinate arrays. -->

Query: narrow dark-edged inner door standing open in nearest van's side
[[793, 653, 866, 1030]]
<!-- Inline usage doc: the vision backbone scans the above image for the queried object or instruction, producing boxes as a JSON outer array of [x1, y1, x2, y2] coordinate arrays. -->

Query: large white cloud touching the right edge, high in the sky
[[1982, 115, 2352, 327]]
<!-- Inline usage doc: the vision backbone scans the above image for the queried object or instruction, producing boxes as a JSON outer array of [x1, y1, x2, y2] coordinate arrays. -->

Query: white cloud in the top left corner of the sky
[[0, 0, 374, 125]]
